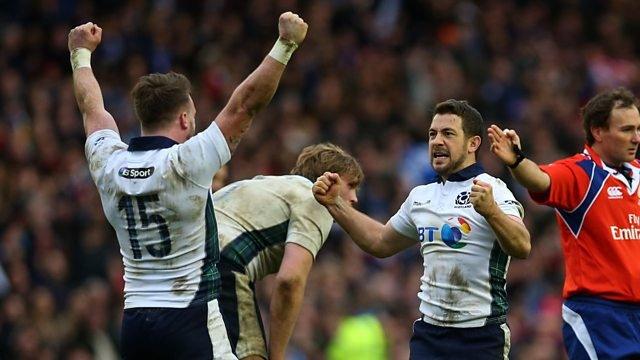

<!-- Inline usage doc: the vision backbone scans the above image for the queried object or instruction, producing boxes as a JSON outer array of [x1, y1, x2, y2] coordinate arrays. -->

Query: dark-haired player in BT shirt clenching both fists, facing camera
[[313, 100, 531, 359]]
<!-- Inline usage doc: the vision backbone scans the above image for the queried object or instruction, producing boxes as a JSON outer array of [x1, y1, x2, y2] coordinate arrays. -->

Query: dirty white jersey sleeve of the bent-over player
[[286, 194, 333, 259]]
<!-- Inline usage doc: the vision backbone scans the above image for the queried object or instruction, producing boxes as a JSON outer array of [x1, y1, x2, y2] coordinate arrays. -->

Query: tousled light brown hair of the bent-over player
[[291, 143, 364, 186]]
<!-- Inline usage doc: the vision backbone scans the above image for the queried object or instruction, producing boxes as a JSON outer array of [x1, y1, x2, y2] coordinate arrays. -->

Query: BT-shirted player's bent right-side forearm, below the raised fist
[[485, 208, 531, 259]]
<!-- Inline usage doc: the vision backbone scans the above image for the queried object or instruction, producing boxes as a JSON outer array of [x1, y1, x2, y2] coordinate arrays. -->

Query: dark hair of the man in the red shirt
[[582, 87, 638, 146]]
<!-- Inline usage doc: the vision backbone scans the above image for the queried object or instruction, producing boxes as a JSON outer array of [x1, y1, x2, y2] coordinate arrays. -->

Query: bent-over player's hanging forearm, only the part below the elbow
[[269, 280, 305, 360]]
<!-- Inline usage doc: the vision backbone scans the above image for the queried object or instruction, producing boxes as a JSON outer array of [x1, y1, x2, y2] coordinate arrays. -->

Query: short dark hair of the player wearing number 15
[[131, 72, 191, 129]]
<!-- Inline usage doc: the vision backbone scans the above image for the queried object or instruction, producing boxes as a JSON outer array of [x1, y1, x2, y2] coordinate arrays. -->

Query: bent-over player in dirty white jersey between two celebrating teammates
[[213, 144, 363, 360]]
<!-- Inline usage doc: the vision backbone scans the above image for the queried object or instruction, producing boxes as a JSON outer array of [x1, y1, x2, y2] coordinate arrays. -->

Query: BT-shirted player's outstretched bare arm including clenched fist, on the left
[[313, 173, 416, 258]]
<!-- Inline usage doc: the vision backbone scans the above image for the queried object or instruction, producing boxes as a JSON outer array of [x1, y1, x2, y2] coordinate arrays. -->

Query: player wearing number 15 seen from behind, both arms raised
[[68, 12, 307, 359]]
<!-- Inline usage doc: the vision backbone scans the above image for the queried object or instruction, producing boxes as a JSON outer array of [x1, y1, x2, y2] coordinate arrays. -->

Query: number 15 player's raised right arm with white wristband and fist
[[215, 12, 307, 152]]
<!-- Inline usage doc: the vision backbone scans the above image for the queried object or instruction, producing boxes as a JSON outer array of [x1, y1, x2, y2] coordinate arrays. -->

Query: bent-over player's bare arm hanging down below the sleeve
[[269, 243, 313, 360]]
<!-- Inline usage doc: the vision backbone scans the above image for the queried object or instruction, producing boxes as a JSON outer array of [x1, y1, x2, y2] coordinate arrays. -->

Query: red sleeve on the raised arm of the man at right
[[529, 159, 588, 210]]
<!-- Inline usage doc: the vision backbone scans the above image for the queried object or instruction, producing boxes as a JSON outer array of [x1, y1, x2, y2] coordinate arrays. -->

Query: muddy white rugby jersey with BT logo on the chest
[[389, 163, 523, 327]]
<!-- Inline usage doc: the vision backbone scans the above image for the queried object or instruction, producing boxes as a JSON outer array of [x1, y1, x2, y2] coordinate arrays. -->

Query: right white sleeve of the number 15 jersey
[[169, 122, 231, 188]]
